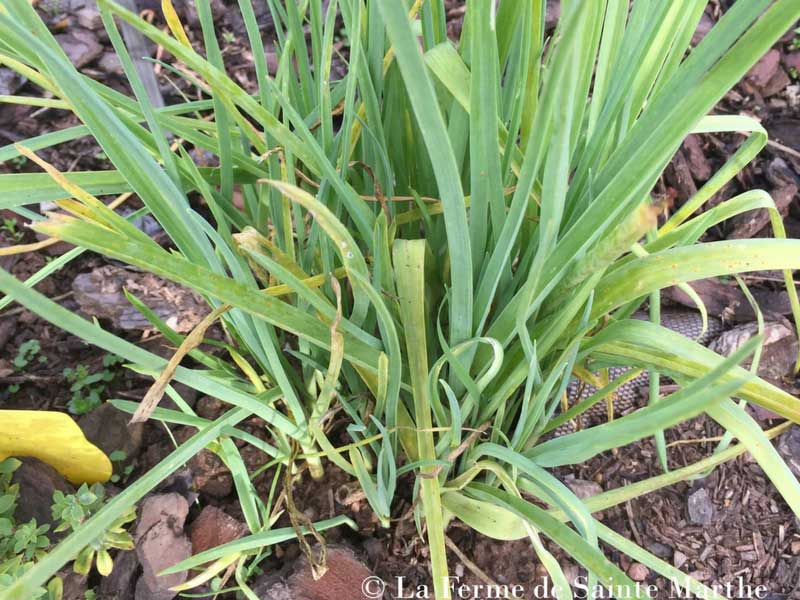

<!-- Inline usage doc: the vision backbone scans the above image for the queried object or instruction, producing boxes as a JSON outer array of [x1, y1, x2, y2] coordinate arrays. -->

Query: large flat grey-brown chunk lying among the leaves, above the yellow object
[[72, 265, 209, 333]]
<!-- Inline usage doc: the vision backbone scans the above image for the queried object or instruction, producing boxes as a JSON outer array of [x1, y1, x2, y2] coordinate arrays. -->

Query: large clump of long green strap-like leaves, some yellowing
[[0, 0, 800, 598]]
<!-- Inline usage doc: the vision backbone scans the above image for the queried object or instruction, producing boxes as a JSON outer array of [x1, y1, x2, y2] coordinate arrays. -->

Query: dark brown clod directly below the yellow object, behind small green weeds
[[12, 457, 75, 539]]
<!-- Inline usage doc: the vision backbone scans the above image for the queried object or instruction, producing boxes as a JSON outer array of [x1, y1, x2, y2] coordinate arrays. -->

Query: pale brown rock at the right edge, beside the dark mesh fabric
[[709, 322, 797, 382]]
